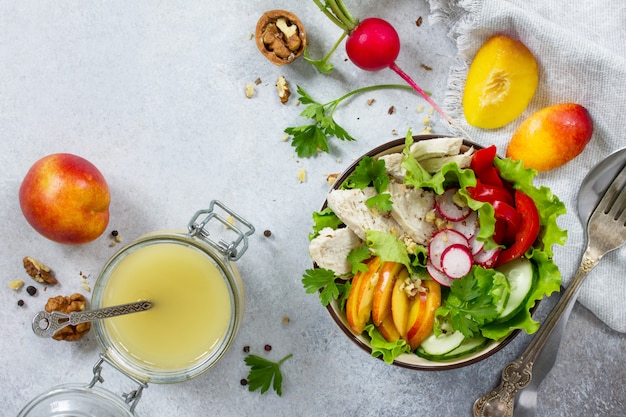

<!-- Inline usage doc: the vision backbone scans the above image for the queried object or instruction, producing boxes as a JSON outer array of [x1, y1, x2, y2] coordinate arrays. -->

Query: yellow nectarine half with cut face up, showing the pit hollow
[[463, 35, 539, 129]]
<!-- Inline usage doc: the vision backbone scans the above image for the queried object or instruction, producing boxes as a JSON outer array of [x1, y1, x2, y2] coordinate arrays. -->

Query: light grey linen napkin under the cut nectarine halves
[[427, 0, 626, 332]]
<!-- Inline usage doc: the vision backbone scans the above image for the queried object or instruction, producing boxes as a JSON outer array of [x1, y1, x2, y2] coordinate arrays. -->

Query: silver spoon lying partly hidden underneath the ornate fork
[[514, 148, 626, 417]]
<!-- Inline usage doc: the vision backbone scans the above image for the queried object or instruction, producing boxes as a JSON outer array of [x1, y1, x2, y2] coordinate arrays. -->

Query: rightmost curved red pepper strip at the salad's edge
[[495, 190, 540, 266]]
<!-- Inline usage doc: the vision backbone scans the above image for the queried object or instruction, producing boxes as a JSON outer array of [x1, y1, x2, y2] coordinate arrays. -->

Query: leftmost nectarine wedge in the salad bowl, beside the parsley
[[346, 257, 380, 335]]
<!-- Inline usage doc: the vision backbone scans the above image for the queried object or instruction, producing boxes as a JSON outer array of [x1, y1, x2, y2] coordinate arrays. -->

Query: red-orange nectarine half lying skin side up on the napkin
[[506, 103, 593, 171]]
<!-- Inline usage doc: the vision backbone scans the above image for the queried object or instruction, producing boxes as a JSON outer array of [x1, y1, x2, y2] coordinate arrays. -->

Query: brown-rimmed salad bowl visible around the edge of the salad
[[303, 135, 565, 370]]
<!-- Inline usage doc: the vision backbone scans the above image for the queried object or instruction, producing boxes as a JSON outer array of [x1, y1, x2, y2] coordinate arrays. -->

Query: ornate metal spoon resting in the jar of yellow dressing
[[33, 300, 152, 337]]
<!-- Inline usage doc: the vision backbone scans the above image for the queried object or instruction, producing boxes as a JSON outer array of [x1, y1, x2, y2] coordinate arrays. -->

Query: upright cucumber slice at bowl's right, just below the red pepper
[[495, 257, 535, 323]]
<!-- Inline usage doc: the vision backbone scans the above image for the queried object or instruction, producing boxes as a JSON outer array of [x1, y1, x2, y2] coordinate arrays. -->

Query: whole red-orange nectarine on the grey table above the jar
[[19, 153, 111, 245]]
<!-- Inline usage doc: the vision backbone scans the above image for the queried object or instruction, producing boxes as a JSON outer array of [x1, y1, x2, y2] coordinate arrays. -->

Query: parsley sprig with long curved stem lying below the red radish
[[285, 84, 412, 158]]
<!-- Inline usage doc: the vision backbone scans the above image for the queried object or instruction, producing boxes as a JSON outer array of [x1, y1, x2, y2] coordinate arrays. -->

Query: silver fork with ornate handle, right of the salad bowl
[[473, 166, 626, 417]]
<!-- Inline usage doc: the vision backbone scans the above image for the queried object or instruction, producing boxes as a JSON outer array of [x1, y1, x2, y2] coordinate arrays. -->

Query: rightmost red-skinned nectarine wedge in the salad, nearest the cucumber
[[406, 280, 441, 350]]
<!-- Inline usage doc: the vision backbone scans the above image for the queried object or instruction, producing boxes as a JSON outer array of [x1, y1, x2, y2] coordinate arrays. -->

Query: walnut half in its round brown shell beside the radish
[[254, 10, 306, 65]]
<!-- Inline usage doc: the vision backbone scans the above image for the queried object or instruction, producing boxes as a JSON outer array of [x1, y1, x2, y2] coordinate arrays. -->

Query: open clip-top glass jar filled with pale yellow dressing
[[19, 200, 254, 417]]
